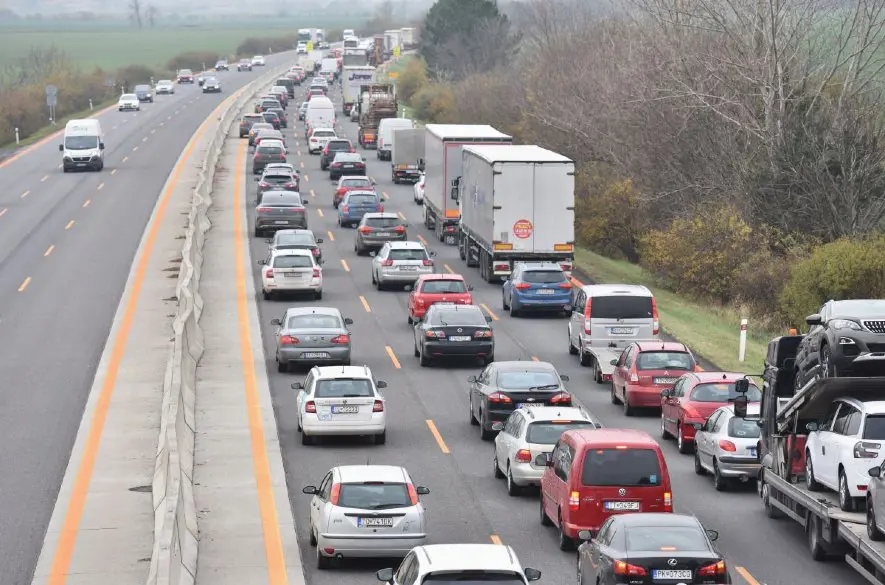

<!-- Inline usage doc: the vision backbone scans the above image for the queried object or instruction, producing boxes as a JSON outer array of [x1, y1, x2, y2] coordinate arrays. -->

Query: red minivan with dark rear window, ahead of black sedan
[[536, 429, 673, 550]]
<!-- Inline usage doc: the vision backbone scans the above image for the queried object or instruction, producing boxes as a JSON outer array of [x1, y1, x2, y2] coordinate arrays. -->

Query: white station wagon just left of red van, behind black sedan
[[492, 406, 602, 496]]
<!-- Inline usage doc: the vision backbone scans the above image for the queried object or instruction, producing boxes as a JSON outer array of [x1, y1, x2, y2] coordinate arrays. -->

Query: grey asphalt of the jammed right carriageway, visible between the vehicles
[[240, 80, 863, 585]]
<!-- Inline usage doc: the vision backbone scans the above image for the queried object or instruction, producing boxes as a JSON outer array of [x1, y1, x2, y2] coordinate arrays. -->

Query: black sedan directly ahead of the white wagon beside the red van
[[462, 360, 572, 441]]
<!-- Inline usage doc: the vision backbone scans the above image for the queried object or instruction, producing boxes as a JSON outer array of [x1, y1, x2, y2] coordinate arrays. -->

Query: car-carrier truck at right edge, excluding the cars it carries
[[748, 336, 885, 585]]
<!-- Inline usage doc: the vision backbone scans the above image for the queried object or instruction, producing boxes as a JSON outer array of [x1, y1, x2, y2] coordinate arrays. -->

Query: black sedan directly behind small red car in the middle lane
[[415, 303, 495, 368]]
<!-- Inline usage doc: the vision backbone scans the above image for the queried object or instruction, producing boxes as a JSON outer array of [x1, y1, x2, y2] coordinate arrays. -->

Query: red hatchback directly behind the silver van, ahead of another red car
[[611, 341, 698, 416]]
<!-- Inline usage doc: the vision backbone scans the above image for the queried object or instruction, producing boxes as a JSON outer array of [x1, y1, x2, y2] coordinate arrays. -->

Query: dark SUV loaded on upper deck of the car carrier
[[795, 300, 885, 390]]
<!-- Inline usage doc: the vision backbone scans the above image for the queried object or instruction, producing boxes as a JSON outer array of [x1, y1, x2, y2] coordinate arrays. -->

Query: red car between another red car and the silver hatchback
[[661, 372, 762, 454]]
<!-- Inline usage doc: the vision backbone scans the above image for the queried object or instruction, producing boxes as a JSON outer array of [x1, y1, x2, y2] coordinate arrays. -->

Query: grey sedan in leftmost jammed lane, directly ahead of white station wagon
[[271, 307, 353, 372]]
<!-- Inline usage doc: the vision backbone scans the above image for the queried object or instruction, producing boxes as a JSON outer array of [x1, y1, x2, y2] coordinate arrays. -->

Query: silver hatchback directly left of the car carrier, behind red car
[[694, 403, 760, 491]]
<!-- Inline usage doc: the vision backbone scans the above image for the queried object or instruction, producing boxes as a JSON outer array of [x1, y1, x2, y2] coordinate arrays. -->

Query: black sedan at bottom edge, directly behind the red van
[[577, 513, 731, 585]]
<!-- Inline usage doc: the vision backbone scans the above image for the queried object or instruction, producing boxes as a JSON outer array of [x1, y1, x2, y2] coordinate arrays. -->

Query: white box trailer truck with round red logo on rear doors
[[452, 144, 575, 282]]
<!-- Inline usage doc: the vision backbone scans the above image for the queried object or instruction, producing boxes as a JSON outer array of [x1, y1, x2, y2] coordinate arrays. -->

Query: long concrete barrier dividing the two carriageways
[[147, 59, 289, 585]]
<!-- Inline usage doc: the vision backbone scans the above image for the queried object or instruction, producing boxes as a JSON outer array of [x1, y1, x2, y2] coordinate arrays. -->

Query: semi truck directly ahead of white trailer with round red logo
[[421, 124, 513, 245]]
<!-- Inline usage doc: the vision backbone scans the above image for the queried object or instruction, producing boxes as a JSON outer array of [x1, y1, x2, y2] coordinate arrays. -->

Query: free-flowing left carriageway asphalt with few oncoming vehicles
[[0, 54, 294, 585]]
